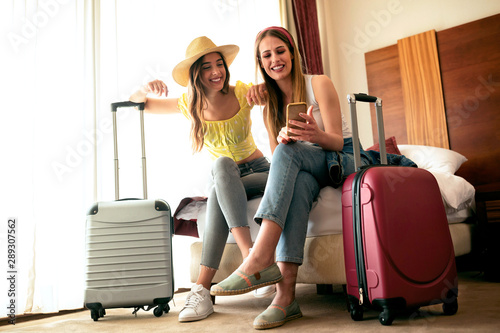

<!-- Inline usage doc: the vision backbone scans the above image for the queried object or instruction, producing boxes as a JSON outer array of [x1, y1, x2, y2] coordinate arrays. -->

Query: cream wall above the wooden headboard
[[317, 0, 500, 147]]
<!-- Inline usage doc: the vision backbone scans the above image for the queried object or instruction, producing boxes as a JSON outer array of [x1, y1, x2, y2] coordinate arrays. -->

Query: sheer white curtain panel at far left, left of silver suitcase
[[0, 1, 94, 313]]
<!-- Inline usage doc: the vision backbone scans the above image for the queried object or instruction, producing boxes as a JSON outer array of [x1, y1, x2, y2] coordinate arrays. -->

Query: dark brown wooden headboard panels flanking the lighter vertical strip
[[365, 14, 500, 186]]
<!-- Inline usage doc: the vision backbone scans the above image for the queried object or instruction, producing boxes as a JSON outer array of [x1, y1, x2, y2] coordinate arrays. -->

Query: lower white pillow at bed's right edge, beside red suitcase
[[429, 171, 476, 213]]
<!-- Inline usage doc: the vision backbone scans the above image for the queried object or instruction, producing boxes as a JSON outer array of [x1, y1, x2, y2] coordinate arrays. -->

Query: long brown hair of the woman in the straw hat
[[188, 52, 229, 153]]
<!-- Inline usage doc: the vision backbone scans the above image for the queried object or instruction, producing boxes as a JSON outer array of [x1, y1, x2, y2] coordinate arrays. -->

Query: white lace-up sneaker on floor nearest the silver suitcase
[[179, 284, 214, 322]]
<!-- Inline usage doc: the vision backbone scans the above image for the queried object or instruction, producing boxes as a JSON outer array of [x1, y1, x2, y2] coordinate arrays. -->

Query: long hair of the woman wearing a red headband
[[255, 27, 306, 137]]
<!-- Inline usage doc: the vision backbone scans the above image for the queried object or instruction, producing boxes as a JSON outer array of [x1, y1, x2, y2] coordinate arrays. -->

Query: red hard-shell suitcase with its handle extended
[[342, 94, 458, 325]]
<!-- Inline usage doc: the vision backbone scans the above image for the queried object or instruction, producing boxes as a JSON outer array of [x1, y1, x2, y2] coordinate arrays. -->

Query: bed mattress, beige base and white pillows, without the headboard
[[175, 141, 475, 285]]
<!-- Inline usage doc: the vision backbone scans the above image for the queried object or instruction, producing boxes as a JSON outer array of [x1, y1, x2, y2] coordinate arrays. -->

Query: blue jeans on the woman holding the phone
[[255, 142, 331, 265]]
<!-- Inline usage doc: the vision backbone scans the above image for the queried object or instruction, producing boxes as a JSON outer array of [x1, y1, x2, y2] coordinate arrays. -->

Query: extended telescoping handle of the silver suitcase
[[111, 101, 148, 200]]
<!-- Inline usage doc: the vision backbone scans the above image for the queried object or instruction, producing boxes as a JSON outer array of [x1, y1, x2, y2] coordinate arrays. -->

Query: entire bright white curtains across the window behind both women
[[0, 0, 280, 314]]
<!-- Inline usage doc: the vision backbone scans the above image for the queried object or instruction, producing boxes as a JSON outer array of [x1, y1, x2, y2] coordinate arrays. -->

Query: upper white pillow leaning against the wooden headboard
[[398, 145, 467, 174]]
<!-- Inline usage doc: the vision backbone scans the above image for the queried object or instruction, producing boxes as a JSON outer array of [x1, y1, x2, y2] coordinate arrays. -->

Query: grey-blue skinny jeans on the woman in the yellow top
[[201, 157, 269, 269]]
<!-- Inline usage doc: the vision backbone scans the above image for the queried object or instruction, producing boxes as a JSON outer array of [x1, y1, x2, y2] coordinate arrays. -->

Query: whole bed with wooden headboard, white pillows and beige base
[[175, 14, 500, 285]]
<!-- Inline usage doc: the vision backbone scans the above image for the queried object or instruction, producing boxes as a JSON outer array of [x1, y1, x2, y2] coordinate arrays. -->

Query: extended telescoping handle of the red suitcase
[[347, 93, 387, 170]]
